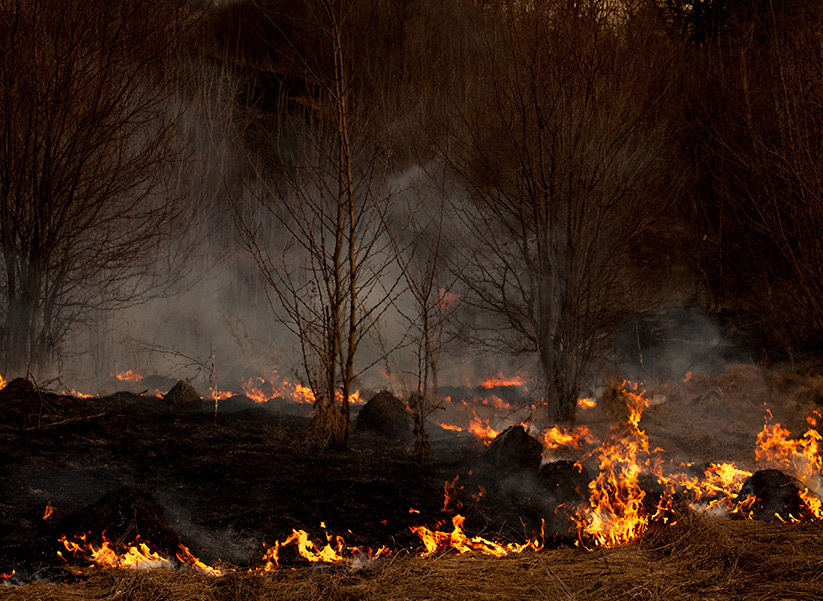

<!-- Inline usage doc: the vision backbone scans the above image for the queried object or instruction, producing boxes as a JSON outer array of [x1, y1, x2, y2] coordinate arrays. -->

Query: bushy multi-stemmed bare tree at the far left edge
[[0, 0, 192, 373]]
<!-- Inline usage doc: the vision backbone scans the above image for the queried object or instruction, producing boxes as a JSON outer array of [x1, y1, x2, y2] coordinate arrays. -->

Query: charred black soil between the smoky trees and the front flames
[[0, 385, 562, 574]]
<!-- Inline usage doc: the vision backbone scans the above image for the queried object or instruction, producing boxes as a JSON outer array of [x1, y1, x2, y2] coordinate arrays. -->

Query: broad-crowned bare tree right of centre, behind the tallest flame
[[447, 0, 670, 421]]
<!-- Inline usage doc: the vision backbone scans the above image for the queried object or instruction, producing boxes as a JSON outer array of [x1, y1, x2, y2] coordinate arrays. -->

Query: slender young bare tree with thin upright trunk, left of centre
[[238, 0, 395, 446]]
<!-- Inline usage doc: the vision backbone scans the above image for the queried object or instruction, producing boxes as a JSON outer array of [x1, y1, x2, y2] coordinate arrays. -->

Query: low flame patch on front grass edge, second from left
[[261, 523, 390, 572]]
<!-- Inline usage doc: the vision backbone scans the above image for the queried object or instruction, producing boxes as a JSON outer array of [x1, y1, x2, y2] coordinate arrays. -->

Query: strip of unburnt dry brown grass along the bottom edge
[[6, 514, 823, 601]]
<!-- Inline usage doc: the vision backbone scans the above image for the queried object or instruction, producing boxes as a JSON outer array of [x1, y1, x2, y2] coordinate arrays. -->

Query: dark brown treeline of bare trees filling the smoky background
[[0, 0, 823, 440]]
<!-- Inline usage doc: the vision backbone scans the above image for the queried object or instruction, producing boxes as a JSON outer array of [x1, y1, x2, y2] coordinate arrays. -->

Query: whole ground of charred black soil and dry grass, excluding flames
[[0, 366, 823, 599]]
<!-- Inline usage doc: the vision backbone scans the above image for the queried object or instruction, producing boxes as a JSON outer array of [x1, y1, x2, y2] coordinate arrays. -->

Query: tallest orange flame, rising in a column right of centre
[[572, 390, 669, 548]]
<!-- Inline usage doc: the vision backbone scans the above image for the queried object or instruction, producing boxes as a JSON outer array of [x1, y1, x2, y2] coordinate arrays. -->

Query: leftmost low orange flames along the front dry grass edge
[[57, 532, 223, 576]]
